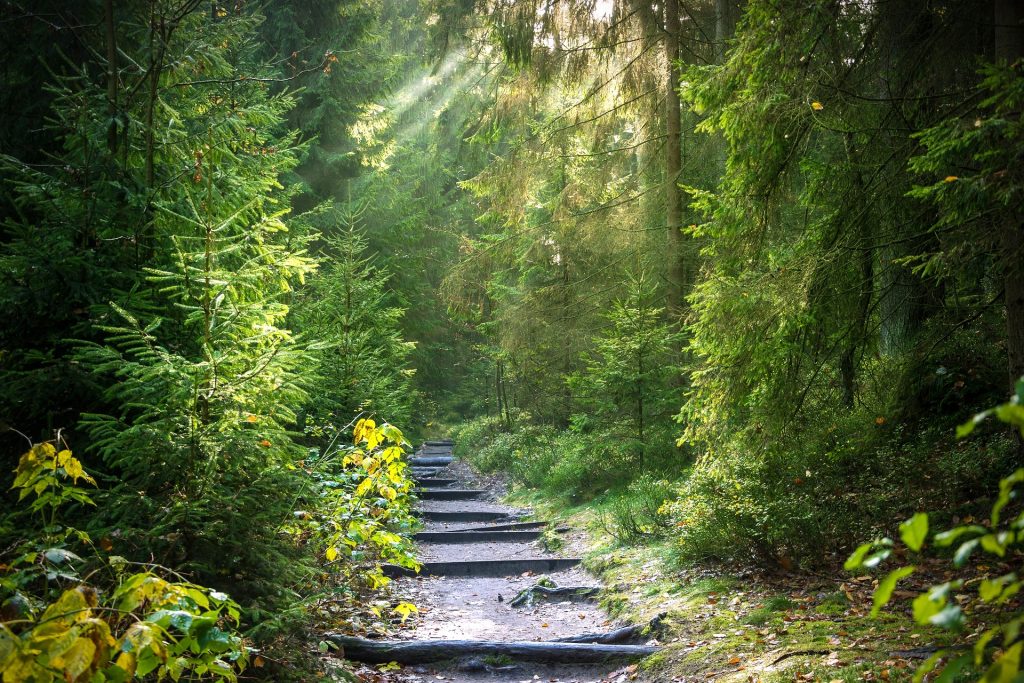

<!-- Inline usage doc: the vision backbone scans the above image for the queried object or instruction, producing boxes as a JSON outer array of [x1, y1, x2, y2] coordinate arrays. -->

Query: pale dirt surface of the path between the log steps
[[352, 443, 647, 683]]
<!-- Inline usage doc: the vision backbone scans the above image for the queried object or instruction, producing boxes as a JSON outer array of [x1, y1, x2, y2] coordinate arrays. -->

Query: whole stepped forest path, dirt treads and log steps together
[[339, 441, 654, 683]]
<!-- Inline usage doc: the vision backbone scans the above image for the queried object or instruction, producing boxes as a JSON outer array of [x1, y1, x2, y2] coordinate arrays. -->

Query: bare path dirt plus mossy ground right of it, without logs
[[339, 450, 962, 683]]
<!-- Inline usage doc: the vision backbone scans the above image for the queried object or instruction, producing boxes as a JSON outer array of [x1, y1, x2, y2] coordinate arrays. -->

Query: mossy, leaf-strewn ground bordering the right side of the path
[[513, 492, 966, 683]]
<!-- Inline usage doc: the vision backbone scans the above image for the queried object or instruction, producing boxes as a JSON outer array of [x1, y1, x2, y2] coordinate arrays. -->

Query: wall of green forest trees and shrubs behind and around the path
[[0, 0, 1024, 680]]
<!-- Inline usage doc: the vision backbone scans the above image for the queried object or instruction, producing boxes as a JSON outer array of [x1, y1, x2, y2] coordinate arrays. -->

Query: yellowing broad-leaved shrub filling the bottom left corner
[[0, 442, 249, 683]]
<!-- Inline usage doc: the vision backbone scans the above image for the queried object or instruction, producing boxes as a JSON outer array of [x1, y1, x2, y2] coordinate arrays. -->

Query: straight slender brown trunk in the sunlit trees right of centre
[[665, 0, 687, 315]]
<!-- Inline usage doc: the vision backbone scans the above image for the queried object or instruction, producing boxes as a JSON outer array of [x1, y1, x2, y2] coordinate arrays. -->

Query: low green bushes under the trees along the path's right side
[[455, 362, 1018, 569]]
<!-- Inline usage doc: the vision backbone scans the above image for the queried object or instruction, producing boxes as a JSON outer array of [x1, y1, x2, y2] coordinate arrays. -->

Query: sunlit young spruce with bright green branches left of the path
[[77, 97, 314, 595]]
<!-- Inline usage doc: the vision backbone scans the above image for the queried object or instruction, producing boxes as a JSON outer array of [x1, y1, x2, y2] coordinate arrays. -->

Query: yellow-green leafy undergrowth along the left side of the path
[[0, 420, 417, 683]]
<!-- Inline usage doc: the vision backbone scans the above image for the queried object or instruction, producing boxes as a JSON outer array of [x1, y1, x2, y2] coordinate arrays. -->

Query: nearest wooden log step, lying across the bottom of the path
[[327, 634, 658, 664]]
